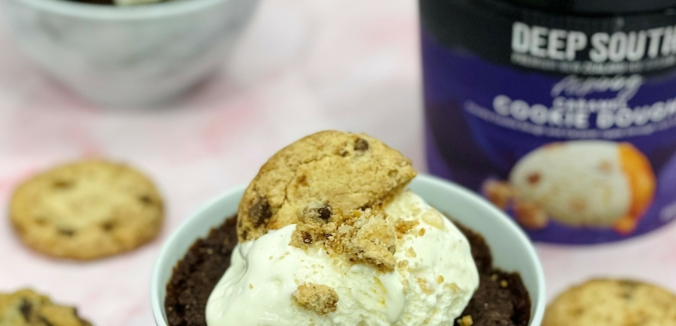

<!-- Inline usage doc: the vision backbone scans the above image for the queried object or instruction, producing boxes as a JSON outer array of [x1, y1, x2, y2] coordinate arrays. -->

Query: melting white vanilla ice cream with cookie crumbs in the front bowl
[[206, 191, 479, 326]]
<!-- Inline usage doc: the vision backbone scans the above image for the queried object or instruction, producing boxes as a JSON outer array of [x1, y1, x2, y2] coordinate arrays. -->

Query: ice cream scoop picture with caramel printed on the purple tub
[[484, 140, 656, 234]]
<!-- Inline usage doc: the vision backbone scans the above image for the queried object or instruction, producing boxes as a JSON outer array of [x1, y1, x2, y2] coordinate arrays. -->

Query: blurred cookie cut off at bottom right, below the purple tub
[[542, 279, 676, 326]]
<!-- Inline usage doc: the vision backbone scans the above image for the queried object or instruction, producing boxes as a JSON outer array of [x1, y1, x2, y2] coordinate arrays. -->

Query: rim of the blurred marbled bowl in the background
[[9, 0, 230, 21]]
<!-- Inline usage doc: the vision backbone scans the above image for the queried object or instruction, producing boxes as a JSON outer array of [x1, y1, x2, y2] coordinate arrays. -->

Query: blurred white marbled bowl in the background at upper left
[[1, 0, 258, 107]]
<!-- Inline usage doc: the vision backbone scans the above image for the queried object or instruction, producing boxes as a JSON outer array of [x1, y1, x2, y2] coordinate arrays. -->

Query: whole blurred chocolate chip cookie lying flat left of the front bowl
[[10, 160, 163, 260]]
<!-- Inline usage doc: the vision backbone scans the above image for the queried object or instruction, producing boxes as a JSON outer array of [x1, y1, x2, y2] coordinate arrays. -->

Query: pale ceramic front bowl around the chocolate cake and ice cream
[[151, 175, 545, 326]]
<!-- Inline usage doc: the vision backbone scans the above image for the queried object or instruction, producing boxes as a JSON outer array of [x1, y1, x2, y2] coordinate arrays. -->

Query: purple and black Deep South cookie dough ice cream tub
[[419, 0, 676, 244]]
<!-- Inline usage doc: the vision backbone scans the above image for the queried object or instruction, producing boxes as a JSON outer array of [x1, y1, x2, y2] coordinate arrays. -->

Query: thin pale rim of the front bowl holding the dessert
[[150, 174, 546, 326]]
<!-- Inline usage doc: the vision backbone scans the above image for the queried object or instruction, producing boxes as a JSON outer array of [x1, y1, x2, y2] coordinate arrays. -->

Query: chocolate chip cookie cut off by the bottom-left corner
[[0, 289, 91, 326]]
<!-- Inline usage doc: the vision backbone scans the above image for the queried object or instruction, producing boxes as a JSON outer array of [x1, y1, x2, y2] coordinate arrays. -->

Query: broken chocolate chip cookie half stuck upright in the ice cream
[[237, 130, 416, 241]]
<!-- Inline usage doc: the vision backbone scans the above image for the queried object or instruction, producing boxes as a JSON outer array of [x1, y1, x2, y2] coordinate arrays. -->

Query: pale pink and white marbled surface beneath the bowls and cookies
[[0, 0, 676, 326]]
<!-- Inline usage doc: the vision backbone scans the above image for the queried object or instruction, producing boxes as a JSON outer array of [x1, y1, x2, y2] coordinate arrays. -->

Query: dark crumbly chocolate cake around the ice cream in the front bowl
[[164, 218, 531, 326]]
